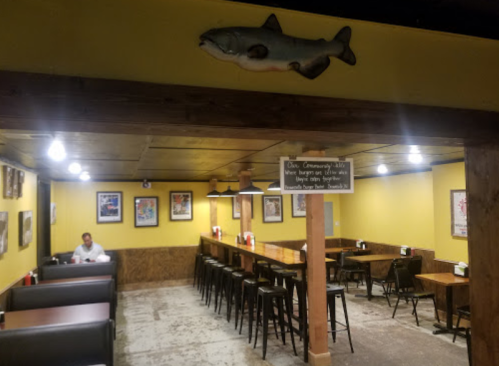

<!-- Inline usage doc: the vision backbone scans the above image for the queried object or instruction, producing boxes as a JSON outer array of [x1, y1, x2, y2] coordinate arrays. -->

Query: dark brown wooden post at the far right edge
[[465, 145, 499, 366]]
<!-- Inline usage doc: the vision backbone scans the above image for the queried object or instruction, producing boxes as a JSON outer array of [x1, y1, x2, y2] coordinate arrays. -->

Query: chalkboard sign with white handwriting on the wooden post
[[281, 157, 353, 194]]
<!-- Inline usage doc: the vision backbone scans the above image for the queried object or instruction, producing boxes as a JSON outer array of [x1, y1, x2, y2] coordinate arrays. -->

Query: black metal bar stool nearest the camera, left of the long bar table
[[253, 286, 298, 360]]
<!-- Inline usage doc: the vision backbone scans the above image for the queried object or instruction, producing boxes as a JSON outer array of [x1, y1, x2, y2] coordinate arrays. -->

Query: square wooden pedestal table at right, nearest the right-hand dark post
[[416, 273, 470, 334]]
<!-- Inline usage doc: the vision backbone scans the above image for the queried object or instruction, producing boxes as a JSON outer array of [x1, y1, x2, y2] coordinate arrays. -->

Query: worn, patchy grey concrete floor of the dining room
[[115, 286, 468, 366]]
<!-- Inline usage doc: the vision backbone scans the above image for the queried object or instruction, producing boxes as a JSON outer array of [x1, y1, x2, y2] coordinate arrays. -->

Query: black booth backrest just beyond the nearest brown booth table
[[9, 280, 116, 320]]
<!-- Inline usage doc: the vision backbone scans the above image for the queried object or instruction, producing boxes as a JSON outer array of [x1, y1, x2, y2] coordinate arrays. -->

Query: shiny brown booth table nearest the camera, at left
[[0, 302, 109, 329]]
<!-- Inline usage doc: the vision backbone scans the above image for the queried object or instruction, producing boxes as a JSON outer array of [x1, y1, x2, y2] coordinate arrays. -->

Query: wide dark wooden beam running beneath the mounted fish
[[0, 71, 499, 146]]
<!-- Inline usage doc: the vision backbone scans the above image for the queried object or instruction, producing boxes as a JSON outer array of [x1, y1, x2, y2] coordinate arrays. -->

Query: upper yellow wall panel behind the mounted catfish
[[0, 0, 499, 111]]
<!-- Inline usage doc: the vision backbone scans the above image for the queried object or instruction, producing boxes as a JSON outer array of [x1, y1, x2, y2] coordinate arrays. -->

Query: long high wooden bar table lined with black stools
[[201, 235, 335, 362]]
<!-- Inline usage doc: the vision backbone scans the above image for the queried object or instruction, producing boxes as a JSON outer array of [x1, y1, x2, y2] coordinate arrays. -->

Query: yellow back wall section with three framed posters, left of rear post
[[52, 182, 210, 253]]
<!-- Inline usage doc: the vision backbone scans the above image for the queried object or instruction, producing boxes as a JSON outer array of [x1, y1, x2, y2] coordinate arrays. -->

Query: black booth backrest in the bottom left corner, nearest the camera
[[0, 320, 113, 366]]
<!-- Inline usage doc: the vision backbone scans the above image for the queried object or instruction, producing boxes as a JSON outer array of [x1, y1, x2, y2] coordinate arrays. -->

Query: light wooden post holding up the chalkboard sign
[[303, 151, 331, 366]]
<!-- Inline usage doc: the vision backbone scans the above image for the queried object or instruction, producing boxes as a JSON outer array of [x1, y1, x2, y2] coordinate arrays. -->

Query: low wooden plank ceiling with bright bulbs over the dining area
[[0, 130, 464, 181]]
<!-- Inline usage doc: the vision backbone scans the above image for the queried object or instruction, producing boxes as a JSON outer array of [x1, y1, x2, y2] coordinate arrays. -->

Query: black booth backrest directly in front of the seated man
[[39, 261, 117, 285]]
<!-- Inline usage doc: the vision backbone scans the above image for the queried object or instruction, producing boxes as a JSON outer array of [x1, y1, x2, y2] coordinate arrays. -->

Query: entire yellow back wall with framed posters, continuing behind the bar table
[[52, 182, 341, 253]]
